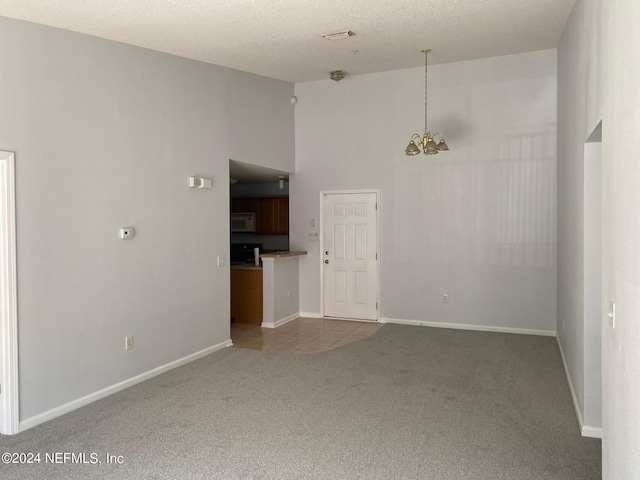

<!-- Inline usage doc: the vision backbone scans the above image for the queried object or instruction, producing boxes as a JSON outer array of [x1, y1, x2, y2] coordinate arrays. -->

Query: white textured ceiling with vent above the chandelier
[[0, 0, 575, 82]]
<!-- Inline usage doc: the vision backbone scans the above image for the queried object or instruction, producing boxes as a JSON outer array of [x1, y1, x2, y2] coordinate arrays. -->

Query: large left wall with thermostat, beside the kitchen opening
[[0, 18, 294, 421]]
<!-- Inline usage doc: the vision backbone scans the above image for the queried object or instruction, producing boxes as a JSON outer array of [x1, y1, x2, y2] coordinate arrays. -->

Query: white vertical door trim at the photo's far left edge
[[0, 151, 20, 435]]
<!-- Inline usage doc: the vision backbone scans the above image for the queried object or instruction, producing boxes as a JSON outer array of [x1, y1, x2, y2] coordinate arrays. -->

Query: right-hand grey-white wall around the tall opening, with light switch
[[558, 0, 640, 480]]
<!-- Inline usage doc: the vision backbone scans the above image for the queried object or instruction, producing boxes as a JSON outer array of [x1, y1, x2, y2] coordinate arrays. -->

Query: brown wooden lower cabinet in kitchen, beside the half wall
[[231, 268, 262, 325]]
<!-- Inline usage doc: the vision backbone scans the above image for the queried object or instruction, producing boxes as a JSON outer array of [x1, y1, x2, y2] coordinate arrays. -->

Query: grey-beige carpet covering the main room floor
[[0, 325, 601, 480]]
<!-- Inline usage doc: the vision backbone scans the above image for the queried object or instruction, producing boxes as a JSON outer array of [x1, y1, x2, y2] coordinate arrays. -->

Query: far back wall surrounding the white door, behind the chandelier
[[290, 50, 556, 332]]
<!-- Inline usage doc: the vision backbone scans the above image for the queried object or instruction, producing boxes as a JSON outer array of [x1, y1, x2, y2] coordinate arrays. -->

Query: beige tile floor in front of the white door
[[231, 318, 383, 354]]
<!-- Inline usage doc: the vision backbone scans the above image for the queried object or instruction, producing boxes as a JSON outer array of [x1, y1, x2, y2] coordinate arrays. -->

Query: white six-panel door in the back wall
[[322, 192, 378, 320]]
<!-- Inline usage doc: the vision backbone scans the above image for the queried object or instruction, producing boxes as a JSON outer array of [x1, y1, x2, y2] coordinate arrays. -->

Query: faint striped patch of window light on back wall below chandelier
[[392, 125, 556, 268]]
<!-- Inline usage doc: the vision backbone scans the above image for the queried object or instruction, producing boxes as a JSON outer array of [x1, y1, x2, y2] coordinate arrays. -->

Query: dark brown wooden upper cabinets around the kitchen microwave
[[231, 197, 289, 235]]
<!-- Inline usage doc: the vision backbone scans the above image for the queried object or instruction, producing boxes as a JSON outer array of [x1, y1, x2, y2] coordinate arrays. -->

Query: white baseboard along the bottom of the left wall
[[19, 340, 232, 432]]
